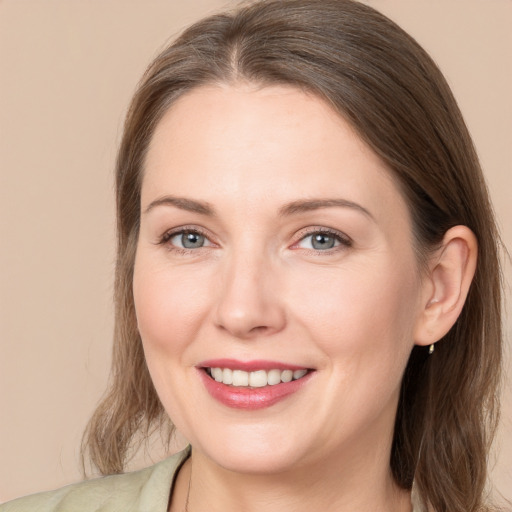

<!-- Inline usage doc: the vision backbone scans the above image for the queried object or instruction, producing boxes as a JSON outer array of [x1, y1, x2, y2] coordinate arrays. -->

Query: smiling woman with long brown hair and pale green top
[[2, 0, 501, 512]]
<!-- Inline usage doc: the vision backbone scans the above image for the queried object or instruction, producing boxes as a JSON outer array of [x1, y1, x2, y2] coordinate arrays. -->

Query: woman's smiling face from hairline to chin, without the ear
[[134, 85, 424, 473]]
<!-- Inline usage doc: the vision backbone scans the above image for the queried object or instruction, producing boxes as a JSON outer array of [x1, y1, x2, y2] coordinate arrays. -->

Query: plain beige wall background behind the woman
[[0, 0, 512, 501]]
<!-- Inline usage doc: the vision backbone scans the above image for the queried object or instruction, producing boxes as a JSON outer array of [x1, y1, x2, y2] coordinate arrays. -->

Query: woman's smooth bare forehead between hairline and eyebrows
[[142, 84, 407, 226]]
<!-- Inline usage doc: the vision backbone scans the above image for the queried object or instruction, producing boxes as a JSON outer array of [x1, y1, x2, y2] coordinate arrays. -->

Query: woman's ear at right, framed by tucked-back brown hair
[[414, 226, 478, 346]]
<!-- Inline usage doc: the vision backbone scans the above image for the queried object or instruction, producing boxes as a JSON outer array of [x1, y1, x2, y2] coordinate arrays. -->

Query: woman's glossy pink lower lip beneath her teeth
[[198, 369, 313, 410]]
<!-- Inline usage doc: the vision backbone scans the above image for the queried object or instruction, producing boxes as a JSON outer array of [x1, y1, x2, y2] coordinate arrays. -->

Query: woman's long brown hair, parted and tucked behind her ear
[[84, 0, 502, 512]]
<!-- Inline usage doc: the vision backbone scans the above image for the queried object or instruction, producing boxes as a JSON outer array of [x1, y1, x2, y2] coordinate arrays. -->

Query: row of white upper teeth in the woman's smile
[[208, 368, 308, 388]]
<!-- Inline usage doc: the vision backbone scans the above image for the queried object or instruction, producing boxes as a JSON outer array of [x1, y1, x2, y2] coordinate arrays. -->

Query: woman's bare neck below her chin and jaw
[[170, 444, 411, 512]]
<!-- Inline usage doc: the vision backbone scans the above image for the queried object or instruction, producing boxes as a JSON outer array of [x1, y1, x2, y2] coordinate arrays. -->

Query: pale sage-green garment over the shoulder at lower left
[[0, 450, 189, 512]]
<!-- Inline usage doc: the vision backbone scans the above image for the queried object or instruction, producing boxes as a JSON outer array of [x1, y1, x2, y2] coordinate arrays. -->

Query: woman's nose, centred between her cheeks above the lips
[[215, 251, 286, 339]]
